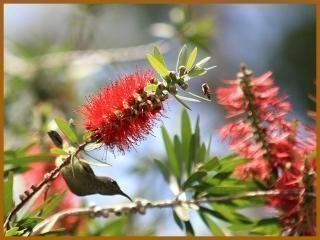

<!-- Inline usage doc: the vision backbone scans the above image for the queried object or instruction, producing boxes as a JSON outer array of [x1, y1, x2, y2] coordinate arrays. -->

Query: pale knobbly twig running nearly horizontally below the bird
[[32, 190, 316, 235]]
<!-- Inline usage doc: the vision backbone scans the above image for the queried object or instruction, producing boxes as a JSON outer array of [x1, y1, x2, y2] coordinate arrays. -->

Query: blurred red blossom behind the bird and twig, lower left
[[22, 147, 81, 231]]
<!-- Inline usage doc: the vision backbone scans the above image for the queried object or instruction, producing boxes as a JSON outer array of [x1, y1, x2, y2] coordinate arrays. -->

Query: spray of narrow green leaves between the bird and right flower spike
[[155, 110, 280, 236]]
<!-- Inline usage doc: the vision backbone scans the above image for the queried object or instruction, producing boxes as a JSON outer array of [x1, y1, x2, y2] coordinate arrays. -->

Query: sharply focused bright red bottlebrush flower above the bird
[[78, 71, 163, 151]]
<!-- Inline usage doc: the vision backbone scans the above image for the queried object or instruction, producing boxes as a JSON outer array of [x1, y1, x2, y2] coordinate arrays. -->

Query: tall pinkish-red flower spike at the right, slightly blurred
[[216, 68, 316, 235]]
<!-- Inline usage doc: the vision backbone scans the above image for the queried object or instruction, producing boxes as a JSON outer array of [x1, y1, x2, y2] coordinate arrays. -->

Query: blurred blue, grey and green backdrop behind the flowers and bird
[[4, 4, 316, 235]]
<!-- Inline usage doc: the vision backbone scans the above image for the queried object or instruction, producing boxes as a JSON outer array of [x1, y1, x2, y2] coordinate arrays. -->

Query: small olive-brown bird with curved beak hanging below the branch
[[61, 157, 132, 202]]
